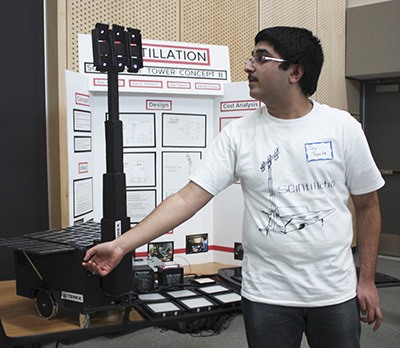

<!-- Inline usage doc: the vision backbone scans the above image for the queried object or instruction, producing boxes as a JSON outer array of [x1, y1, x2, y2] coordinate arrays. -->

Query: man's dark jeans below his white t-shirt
[[242, 298, 361, 348]]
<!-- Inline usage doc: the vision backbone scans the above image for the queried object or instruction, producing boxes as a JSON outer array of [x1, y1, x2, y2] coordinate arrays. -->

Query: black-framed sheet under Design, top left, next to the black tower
[[119, 112, 156, 147]]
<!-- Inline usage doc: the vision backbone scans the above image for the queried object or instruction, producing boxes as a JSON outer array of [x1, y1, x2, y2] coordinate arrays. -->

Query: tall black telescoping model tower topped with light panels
[[92, 23, 143, 296]]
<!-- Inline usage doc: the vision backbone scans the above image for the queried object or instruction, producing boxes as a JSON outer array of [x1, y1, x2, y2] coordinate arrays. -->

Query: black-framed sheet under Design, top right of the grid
[[162, 113, 207, 147]]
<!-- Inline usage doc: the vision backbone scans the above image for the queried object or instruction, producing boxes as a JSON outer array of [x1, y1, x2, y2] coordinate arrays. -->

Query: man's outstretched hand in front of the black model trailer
[[82, 242, 124, 277]]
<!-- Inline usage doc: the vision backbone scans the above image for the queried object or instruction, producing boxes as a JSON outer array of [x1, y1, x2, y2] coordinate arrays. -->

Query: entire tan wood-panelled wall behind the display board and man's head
[[50, 0, 346, 226]]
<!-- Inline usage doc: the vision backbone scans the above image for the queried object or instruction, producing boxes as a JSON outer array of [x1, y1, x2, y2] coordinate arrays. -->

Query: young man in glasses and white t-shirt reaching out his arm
[[83, 27, 384, 348]]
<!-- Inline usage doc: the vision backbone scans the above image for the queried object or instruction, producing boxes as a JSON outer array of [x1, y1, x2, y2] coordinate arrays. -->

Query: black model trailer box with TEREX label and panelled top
[[0, 222, 132, 319]]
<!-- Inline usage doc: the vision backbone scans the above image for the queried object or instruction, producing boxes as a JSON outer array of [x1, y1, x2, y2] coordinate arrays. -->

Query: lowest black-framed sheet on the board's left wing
[[73, 178, 93, 218]]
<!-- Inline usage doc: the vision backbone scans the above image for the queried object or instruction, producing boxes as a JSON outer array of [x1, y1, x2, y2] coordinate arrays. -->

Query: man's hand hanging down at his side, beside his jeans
[[357, 282, 383, 331]]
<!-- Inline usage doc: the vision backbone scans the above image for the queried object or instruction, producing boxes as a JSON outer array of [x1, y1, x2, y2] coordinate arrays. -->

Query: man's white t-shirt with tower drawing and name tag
[[190, 102, 384, 307]]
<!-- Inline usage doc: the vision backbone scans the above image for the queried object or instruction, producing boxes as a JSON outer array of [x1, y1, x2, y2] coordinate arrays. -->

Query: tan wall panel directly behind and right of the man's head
[[260, 0, 347, 109]]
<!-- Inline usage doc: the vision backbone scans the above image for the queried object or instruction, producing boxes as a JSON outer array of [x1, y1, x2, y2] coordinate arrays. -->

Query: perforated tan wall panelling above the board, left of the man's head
[[67, 0, 259, 81]]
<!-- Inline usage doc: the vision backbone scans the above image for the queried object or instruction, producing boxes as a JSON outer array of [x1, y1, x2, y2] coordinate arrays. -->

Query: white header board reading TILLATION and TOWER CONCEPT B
[[78, 34, 231, 96]]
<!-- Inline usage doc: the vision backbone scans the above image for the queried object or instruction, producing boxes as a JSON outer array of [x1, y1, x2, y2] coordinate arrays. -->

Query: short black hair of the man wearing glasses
[[255, 27, 324, 97]]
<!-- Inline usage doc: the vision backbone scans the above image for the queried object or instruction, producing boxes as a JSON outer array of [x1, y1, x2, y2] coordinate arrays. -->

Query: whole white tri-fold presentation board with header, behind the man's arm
[[66, 35, 260, 264]]
